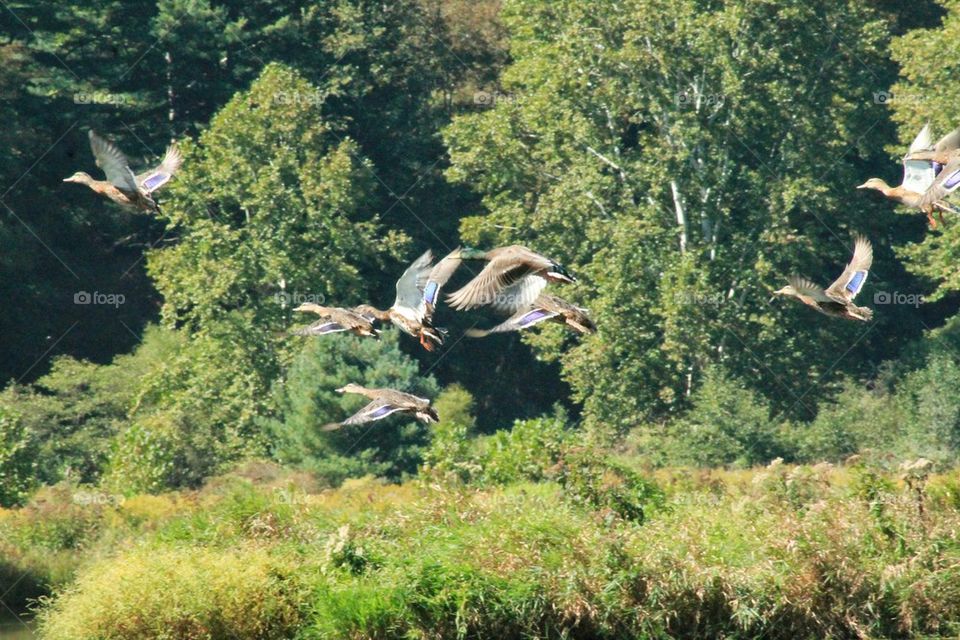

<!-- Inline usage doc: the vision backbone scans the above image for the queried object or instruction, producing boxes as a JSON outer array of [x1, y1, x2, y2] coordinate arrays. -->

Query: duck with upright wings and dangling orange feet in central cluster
[[355, 249, 460, 351]]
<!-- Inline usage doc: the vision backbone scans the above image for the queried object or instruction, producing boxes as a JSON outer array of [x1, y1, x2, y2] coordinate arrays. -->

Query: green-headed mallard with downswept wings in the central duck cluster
[[447, 245, 576, 313]]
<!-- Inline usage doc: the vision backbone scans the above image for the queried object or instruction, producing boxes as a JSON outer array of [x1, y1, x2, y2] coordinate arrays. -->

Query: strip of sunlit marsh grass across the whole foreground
[[0, 464, 960, 640]]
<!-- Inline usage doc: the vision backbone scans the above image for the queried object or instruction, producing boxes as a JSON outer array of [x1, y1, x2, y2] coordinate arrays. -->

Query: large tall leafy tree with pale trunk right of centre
[[445, 0, 920, 430]]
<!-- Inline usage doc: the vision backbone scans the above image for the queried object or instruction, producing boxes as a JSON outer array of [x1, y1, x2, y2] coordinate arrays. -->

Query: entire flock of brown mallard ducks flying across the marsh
[[64, 125, 960, 431]]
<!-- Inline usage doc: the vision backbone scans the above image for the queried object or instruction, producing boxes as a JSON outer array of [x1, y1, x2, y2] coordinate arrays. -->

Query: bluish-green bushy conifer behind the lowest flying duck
[[265, 330, 443, 485]]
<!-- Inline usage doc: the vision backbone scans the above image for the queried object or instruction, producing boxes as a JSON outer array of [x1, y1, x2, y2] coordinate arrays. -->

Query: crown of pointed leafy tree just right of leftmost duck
[[148, 64, 402, 330]]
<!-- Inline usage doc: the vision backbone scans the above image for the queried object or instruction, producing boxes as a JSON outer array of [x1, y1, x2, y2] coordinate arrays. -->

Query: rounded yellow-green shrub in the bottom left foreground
[[40, 545, 306, 640]]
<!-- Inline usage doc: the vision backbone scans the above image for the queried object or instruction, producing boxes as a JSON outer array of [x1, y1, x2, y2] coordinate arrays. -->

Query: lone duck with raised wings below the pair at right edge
[[774, 235, 873, 322]]
